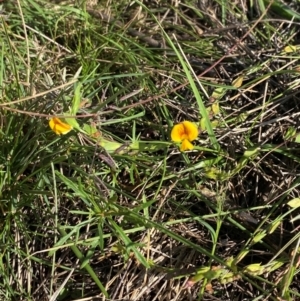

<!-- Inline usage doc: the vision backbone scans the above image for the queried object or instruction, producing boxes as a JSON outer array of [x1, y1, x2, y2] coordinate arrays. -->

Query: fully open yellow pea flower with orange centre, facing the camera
[[171, 121, 198, 152]]
